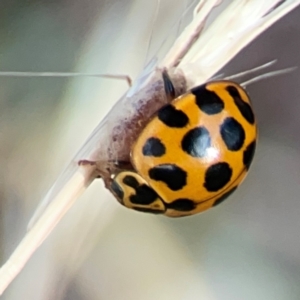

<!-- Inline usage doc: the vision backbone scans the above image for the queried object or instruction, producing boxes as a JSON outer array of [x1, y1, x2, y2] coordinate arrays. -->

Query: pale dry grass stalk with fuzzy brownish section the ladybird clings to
[[0, 0, 300, 294]]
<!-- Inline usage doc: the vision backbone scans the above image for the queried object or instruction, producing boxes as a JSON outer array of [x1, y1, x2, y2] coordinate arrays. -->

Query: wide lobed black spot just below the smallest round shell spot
[[149, 164, 187, 191]]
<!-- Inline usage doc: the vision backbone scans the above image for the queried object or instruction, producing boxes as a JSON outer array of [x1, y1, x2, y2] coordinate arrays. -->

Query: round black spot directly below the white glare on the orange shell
[[204, 162, 232, 192]]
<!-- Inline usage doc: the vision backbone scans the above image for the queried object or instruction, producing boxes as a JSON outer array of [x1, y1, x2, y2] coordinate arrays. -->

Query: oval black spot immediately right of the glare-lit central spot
[[220, 118, 246, 151]]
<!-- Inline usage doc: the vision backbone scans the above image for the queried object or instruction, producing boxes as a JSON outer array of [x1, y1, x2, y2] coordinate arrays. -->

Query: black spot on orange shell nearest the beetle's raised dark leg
[[157, 104, 189, 128]]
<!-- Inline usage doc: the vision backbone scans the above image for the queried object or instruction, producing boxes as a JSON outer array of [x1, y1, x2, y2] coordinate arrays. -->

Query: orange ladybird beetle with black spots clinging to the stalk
[[111, 72, 257, 217]]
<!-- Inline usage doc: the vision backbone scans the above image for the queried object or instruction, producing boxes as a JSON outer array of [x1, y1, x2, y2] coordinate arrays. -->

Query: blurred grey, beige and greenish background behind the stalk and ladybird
[[0, 0, 300, 300]]
